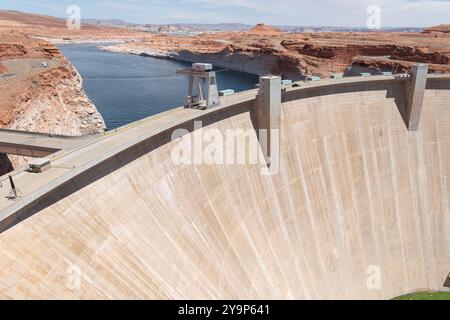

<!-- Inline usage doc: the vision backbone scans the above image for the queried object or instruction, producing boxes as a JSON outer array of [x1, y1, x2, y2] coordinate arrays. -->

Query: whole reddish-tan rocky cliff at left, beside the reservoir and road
[[0, 32, 105, 174]]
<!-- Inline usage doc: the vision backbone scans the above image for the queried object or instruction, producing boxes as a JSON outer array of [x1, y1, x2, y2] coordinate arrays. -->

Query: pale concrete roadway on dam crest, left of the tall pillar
[[0, 90, 257, 232]]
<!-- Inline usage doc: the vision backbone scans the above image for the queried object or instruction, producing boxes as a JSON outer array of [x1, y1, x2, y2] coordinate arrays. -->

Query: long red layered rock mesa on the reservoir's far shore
[[103, 24, 450, 79]]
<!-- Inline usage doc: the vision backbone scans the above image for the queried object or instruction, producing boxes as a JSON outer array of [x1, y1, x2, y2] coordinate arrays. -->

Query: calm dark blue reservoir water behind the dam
[[59, 44, 258, 130]]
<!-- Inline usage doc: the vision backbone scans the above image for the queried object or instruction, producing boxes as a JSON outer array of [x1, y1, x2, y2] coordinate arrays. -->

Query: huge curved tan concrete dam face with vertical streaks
[[0, 77, 450, 299]]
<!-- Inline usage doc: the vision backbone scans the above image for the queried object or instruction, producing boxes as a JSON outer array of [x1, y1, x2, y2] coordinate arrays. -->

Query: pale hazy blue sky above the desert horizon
[[0, 0, 450, 27]]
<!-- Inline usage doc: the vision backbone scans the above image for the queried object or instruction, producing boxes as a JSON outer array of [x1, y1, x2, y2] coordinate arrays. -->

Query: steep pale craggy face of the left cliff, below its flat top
[[8, 65, 105, 135]]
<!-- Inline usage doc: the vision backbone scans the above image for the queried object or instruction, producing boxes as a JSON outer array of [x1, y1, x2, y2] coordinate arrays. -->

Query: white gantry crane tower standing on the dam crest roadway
[[177, 63, 220, 109]]
